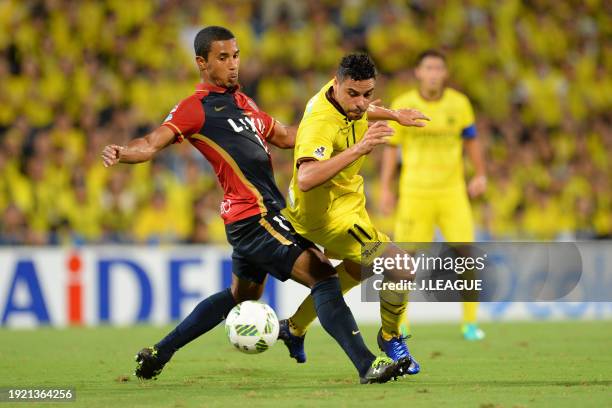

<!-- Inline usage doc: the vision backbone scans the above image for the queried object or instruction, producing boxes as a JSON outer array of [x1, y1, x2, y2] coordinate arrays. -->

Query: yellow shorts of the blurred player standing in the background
[[394, 188, 474, 242]]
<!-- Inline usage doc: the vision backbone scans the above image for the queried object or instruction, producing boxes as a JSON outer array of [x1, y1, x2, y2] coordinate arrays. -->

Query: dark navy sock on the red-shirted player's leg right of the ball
[[310, 278, 375, 377]]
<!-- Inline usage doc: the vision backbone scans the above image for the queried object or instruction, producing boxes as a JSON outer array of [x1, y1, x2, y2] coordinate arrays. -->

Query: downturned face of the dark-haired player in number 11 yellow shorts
[[334, 78, 376, 120]]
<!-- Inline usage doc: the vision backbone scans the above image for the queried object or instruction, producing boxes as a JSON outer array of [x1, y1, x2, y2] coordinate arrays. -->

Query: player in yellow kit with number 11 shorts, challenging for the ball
[[279, 54, 427, 374]]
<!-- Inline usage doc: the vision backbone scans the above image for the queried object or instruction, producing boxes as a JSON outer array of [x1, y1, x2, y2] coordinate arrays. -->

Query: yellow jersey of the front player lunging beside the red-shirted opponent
[[283, 81, 368, 233]]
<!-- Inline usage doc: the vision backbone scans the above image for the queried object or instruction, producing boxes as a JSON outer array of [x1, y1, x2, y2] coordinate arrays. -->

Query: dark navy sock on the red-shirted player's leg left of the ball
[[155, 288, 236, 361]]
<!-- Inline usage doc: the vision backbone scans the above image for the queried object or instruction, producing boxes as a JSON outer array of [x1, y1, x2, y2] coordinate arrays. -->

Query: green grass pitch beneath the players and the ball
[[0, 321, 612, 408]]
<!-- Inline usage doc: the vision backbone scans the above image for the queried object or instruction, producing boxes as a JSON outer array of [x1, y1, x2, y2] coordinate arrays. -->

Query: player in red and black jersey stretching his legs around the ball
[[102, 26, 410, 383]]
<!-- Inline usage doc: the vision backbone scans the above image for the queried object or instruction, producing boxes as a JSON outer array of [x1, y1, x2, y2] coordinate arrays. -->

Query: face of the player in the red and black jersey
[[196, 38, 240, 88]]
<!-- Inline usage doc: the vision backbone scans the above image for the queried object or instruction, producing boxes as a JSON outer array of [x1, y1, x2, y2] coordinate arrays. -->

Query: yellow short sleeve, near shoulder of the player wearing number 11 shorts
[[295, 120, 336, 166]]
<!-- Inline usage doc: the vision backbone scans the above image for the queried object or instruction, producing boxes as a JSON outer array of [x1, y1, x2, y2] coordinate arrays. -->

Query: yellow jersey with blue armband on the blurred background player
[[389, 88, 476, 196]]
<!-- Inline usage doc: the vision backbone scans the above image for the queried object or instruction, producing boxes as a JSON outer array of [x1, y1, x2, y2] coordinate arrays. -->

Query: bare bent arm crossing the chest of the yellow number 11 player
[[296, 122, 393, 191]]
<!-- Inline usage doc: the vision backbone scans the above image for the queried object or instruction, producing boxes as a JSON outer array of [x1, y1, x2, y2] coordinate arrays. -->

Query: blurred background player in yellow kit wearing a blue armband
[[381, 50, 487, 340]]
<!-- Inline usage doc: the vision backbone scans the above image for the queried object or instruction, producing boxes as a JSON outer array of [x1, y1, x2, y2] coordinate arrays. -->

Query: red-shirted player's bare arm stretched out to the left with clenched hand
[[102, 126, 175, 167]]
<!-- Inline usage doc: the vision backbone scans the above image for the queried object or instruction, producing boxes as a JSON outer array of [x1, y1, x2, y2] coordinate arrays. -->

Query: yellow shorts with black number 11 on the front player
[[283, 194, 391, 264]]
